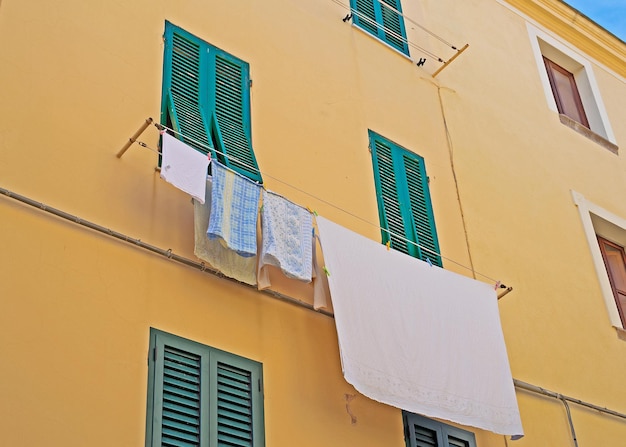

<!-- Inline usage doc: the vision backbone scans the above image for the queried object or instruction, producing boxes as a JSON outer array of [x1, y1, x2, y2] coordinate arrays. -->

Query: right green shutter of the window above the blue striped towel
[[214, 50, 261, 182]]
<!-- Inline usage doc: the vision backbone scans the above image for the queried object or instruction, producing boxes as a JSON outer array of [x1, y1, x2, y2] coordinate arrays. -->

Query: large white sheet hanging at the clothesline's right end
[[317, 217, 523, 438]]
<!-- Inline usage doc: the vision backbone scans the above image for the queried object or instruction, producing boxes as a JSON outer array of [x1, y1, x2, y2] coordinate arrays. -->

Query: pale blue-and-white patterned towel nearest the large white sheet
[[258, 191, 313, 289]]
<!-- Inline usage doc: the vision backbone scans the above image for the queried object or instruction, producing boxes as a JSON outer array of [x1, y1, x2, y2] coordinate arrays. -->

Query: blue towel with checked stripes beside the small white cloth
[[207, 160, 261, 257]]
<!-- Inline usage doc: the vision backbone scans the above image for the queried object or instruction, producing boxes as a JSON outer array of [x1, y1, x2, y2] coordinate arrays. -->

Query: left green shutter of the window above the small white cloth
[[161, 23, 213, 157]]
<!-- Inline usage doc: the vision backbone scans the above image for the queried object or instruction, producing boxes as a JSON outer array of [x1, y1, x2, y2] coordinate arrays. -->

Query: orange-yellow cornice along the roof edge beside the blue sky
[[506, 0, 626, 78]]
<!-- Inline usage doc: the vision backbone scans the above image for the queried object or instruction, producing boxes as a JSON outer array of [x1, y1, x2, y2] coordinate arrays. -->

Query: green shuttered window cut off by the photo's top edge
[[350, 0, 409, 55]]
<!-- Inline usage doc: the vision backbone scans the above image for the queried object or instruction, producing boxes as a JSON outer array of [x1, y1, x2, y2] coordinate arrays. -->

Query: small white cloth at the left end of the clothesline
[[161, 133, 209, 203]]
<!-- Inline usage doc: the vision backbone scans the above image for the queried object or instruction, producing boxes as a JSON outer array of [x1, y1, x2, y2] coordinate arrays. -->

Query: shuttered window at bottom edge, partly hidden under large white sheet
[[402, 411, 476, 447]]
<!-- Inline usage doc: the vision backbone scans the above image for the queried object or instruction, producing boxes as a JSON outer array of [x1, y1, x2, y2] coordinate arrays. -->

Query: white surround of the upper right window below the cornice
[[526, 23, 617, 144]]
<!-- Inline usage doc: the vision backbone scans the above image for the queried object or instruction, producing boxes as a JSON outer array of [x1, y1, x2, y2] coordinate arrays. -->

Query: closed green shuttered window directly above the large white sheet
[[369, 130, 442, 267]]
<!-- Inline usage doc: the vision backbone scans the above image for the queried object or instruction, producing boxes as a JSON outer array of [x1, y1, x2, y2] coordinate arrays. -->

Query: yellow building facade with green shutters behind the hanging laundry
[[0, 0, 626, 447]]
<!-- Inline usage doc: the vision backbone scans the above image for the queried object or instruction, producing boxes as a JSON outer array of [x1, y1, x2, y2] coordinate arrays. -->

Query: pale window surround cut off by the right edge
[[572, 191, 626, 329]]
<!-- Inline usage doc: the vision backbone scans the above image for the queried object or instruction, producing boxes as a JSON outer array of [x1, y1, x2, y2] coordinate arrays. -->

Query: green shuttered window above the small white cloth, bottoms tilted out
[[161, 22, 262, 182]]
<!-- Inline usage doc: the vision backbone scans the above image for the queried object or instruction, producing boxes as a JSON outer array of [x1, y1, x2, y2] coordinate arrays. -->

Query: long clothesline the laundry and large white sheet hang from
[[125, 122, 506, 288]]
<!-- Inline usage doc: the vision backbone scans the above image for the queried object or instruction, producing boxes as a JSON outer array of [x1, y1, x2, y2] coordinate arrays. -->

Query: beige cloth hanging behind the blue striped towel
[[194, 177, 257, 285]]
